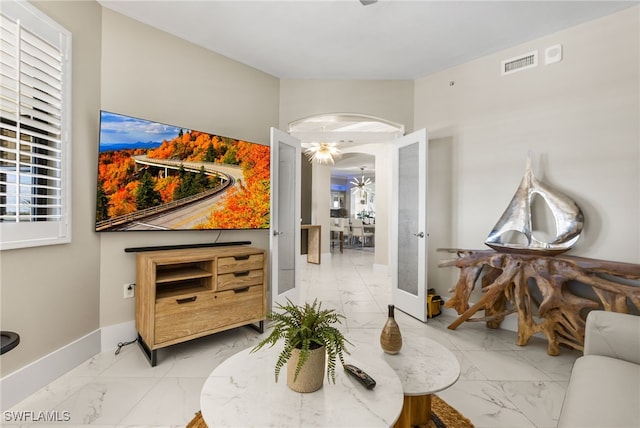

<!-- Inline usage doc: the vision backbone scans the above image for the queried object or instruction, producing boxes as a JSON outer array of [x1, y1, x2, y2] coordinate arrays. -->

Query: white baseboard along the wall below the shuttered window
[[0, 329, 100, 411]]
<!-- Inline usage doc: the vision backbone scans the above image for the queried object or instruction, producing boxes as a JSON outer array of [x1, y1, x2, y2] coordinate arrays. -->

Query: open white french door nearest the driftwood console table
[[391, 129, 428, 321]]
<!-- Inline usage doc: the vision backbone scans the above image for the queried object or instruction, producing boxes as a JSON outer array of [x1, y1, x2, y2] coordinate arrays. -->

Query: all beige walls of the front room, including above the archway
[[0, 1, 640, 382]]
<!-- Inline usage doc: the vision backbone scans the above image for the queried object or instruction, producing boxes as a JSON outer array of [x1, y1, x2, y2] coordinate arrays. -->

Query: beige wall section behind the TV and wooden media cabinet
[[100, 9, 279, 328]]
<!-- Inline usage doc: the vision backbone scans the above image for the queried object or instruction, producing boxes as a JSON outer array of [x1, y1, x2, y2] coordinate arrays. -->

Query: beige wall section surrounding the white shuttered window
[[0, 1, 101, 376]]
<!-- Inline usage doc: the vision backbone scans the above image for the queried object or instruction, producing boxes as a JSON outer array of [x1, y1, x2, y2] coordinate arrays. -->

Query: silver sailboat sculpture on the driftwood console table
[[485, 155, 584, 255]]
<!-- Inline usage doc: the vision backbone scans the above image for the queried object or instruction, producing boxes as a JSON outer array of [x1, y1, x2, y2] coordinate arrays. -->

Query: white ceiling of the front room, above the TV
[[99, 0, 638, 80]]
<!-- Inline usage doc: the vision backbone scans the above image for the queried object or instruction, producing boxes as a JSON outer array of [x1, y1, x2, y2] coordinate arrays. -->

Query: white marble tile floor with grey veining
[[0, 249, 580, 428]]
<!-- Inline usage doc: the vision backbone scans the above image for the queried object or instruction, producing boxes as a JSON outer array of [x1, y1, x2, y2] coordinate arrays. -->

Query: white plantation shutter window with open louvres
[[0, 0, 71, 250]]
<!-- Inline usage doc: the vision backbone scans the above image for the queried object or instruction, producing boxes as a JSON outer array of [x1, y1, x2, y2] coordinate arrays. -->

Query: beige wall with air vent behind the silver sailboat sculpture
[[414, 7, 640, 293]]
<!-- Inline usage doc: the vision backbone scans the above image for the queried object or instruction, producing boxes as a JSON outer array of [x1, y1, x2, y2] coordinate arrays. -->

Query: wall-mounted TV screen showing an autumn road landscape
[[96, 111, 270, 231]]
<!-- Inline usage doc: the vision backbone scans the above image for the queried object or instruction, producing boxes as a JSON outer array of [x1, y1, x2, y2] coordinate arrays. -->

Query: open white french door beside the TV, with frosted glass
[[269, 128, 302, 309]]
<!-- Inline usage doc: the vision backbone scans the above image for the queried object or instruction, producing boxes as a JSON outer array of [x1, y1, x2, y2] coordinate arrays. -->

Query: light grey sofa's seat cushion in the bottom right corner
[[558, 355, 640, 428]]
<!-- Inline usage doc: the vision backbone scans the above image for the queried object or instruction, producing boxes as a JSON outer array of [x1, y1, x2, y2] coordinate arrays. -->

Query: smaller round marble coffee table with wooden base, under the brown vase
[[349, 330, 460, 427]]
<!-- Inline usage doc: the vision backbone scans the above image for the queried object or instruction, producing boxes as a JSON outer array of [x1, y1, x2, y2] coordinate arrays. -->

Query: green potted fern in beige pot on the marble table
[[251, 299, 353, 392]]
